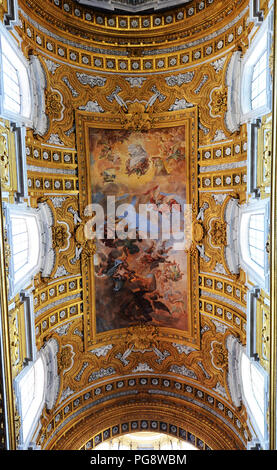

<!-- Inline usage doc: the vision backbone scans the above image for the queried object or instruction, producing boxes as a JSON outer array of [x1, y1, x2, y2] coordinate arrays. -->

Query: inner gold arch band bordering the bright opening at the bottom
[[44, 397, 245, 450]]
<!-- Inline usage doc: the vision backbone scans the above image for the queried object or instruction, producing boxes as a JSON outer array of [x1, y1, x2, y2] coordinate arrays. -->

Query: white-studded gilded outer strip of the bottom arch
[[38, 375, 249, 449]]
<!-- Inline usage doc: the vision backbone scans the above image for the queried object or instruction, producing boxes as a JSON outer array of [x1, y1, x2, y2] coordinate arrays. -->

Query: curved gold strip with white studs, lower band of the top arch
[[19, 5, 248, 73]]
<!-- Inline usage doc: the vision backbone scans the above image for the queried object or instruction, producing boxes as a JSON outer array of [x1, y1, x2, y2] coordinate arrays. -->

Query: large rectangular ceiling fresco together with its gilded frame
[[77, 108, 199, 343]]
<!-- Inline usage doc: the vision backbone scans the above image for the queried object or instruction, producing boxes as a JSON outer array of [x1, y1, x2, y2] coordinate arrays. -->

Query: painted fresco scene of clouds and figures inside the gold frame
[[89, 125, 189, 333]]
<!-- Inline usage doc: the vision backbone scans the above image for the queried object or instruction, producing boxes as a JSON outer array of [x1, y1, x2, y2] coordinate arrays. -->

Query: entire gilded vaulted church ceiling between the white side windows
[[7, 0, 266, 449]]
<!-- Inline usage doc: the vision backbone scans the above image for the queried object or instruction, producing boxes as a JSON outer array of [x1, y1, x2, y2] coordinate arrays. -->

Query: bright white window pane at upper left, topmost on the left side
[[0, 27, 32, 124]]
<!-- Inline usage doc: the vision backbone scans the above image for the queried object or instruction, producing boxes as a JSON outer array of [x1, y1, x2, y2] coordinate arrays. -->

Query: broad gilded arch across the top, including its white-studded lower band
[[18, 0, 250, 74]]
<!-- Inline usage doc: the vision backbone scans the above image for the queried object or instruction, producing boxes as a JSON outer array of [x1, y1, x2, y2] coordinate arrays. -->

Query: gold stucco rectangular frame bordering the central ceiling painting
[[75, 107, 200, 350]]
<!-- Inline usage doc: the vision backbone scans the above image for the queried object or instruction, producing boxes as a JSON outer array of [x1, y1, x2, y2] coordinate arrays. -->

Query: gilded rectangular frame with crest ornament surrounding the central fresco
[[76, 106, 199, 349]]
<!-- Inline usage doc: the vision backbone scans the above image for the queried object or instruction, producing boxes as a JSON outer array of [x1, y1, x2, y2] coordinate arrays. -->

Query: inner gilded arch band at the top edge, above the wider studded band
[[19, 0, 247, 44]]
